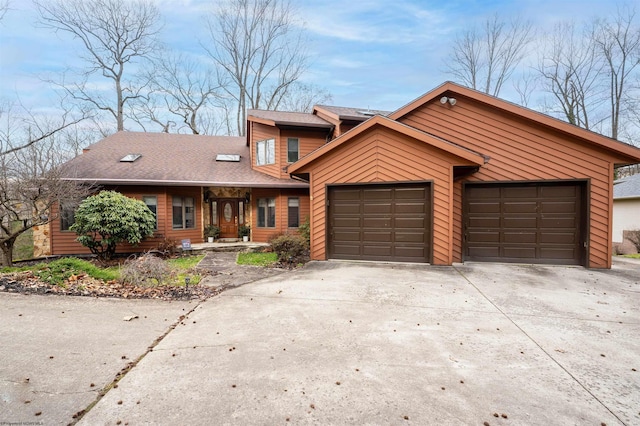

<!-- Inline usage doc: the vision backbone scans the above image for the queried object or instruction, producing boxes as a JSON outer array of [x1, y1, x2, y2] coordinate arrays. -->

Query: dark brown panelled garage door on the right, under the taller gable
[[463, 182, 586, 265]]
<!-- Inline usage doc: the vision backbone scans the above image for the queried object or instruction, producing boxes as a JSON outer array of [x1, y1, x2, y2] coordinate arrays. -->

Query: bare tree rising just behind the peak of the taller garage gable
[[446, 14, 533, 96]]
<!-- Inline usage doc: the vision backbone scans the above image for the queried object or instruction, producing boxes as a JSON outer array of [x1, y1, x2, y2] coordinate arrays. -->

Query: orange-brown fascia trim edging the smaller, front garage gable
[[287, 115, 488, 174]]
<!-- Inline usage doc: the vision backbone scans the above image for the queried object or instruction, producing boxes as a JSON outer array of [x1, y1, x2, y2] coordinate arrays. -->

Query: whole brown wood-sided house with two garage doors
[[42, 83, 640, 268]]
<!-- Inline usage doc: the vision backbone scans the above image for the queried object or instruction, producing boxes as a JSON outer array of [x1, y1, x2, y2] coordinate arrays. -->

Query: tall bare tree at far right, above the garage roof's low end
[[595, 6, 640, 139]]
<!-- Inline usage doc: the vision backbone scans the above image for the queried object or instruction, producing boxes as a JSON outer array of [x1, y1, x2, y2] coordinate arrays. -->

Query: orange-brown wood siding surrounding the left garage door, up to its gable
[[310, 129, 476, 265]]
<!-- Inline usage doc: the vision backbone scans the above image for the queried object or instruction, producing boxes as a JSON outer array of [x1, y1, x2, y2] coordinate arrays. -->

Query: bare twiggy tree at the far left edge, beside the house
[[0, 106, 91, 266]]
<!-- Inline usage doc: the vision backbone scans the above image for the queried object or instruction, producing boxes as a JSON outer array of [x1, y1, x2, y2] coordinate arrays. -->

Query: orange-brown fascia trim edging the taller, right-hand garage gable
[[389, 81, 640, 165]]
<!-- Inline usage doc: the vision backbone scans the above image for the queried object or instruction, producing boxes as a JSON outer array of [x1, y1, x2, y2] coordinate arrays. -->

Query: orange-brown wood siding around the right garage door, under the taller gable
[[398, 96, 614, 268]]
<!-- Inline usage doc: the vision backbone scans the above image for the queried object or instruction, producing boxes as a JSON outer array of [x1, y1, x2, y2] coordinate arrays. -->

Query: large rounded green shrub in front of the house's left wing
[[69, 191, 156, 260]]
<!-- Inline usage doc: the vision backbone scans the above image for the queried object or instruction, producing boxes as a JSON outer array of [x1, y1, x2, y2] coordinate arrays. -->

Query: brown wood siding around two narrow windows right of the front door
[[251, 188, 309, 243]]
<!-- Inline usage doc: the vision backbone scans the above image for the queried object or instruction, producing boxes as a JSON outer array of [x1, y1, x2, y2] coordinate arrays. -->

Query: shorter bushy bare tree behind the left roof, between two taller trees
[[137, 53, 220, 135]]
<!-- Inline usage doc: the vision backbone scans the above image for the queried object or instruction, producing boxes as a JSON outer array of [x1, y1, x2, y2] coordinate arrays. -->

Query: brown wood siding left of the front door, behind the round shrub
[[51, 186, 204, 255]]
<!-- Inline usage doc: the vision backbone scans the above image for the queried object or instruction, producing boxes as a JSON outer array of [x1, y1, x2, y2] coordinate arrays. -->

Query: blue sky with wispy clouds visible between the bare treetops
[[0, 0, 615, 120]]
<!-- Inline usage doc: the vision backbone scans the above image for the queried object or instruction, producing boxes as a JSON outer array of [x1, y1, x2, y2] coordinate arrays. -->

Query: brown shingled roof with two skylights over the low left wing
[[61, 132, 307, 188]]
